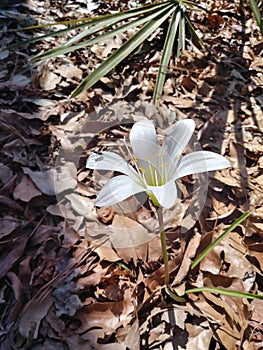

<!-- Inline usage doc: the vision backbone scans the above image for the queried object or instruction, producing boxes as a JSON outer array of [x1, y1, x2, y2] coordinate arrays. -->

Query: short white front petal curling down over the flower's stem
[[148, 181, 177, 209]]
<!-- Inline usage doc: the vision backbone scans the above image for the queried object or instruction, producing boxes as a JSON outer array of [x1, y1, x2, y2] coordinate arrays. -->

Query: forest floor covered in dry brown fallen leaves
[[0, 0, 263, 350]]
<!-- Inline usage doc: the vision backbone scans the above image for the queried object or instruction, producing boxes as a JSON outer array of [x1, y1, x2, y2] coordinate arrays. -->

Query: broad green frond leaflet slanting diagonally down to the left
[[71, 4, 173, 97]]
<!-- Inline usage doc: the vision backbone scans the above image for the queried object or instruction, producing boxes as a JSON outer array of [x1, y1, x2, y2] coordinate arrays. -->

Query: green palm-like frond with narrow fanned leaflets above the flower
[[18, 0, 207, 103]]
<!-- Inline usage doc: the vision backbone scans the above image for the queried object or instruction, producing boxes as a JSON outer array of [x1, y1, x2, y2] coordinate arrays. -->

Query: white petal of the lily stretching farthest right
[[174, 151, 231, 179]]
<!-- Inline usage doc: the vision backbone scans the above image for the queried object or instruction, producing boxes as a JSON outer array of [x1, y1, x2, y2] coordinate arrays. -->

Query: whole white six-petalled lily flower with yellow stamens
[[86, 118, 230, 209]]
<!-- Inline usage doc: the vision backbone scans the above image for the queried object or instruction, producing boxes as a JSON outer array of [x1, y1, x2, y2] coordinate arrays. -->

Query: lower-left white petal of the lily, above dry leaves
[[95, 175, 145, 207]]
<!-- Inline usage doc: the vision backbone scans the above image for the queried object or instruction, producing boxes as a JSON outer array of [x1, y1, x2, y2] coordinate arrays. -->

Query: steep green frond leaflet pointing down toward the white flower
[[153, 6, 180, 104]]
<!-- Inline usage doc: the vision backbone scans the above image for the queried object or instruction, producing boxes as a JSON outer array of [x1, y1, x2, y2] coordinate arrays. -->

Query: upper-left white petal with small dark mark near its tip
[[86, 151, 138, 178]]
